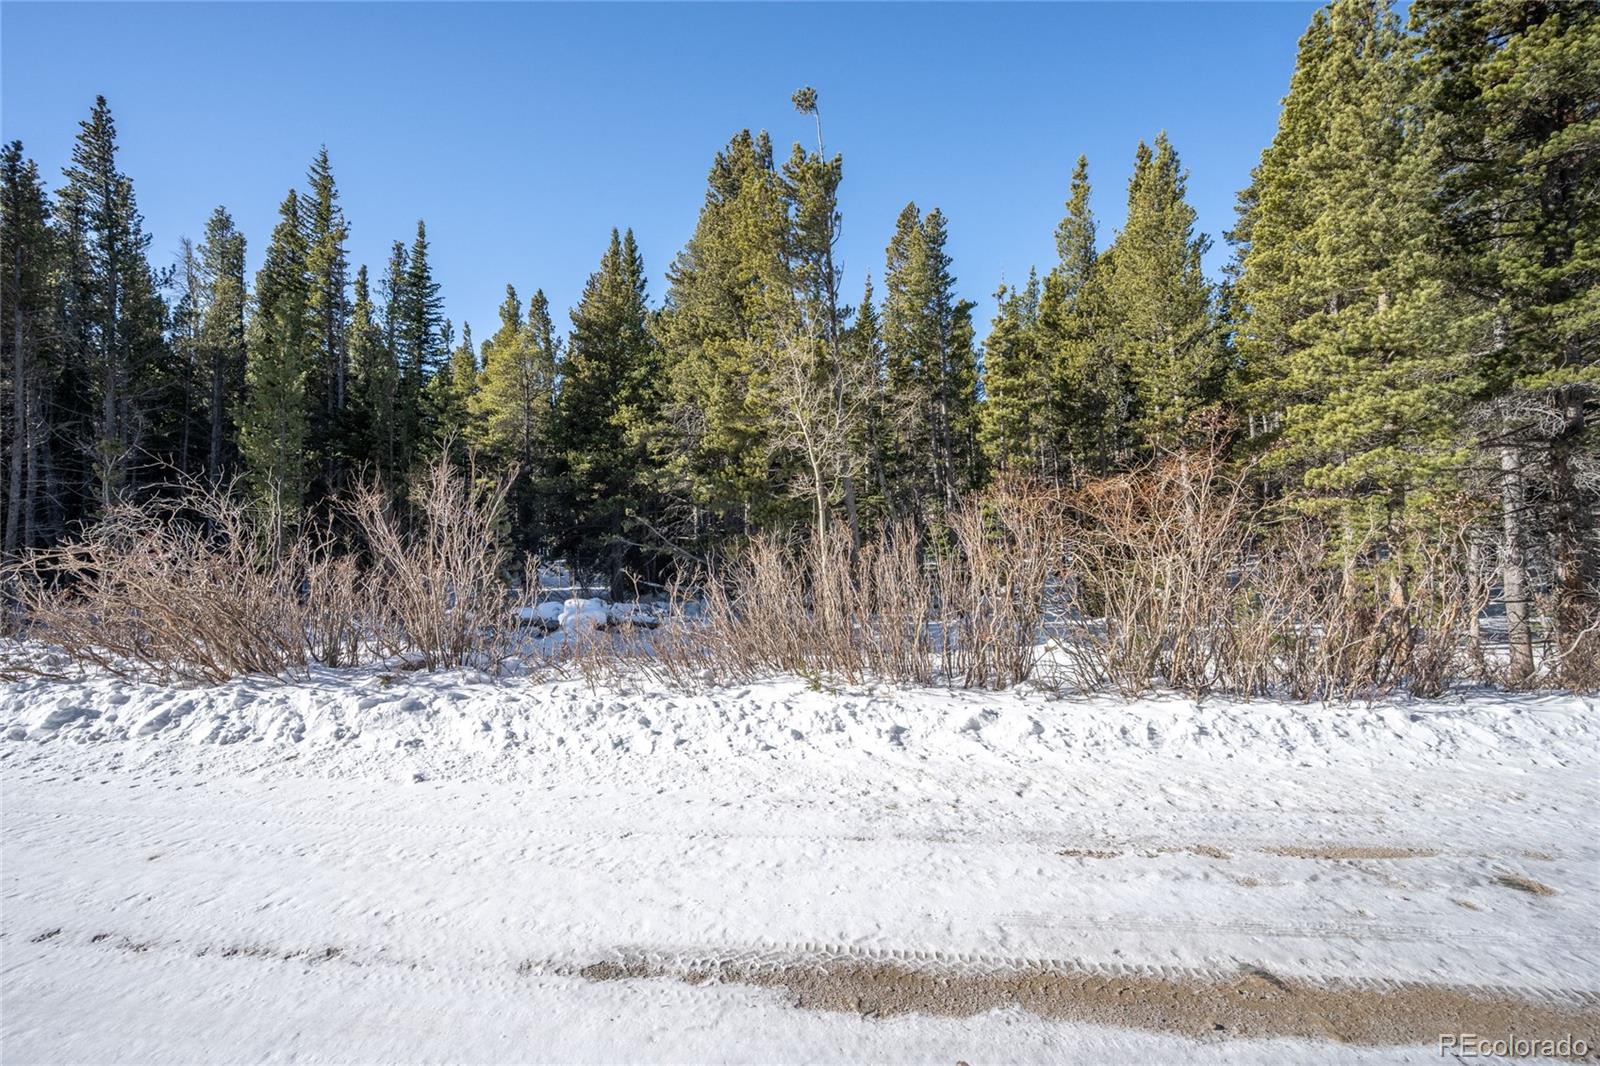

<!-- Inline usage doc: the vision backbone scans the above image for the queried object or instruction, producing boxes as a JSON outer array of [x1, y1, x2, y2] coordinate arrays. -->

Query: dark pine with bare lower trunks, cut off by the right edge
[[1411, 0, 1600, 679]]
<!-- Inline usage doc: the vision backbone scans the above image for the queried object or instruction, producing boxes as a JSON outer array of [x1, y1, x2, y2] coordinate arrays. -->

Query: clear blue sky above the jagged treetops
[[0, 0, 1315, 339]]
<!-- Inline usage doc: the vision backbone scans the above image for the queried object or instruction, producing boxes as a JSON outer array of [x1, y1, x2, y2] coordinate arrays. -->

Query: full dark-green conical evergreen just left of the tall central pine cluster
[[555, 229, 659, 584]]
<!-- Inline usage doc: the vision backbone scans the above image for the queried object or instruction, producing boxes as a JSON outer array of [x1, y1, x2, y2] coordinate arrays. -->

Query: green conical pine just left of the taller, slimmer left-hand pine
[[238, 189, 317, 520]]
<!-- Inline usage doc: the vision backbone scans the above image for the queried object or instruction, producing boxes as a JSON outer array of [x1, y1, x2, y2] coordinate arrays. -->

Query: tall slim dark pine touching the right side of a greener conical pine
[[302, 146, 350, 491]]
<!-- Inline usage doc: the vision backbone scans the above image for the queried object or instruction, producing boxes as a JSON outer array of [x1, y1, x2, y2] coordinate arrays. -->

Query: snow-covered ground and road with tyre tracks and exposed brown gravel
[[0, 659, 1600, 1063]]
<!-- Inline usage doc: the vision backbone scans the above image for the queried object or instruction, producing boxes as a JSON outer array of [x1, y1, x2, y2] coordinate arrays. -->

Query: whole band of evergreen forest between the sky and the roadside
[[0, 0, 1600, 695]]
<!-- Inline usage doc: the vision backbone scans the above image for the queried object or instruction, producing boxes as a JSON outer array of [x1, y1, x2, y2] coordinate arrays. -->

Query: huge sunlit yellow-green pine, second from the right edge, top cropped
[[1235, 0, 1475, 541]]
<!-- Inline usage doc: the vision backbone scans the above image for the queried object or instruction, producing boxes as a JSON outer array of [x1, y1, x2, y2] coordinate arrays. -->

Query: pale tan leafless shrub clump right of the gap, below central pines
[[674, 483, 1062, 688]]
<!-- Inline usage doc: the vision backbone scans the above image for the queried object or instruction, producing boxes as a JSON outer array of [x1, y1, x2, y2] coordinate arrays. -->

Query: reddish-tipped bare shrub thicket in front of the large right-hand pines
[[1059, 445, 1490, 699]]
